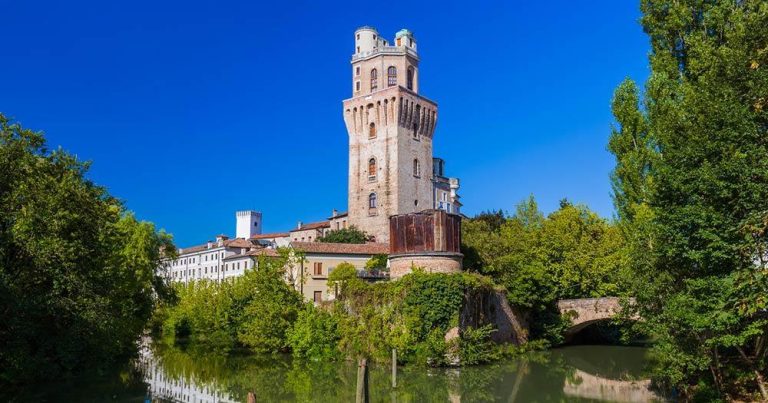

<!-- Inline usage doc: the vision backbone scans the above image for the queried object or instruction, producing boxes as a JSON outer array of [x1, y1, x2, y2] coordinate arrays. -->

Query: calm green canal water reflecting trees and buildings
[[6, 345, 661, 402]]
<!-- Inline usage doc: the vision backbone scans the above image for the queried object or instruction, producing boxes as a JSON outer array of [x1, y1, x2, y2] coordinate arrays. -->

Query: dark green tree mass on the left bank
[[0, 114, 175, 384]]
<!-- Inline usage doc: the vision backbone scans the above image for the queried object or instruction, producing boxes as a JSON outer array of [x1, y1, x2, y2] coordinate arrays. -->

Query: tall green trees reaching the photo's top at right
[[609, 0, 768, 400]]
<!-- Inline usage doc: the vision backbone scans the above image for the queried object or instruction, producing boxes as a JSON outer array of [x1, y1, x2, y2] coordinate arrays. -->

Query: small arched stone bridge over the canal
[[557, 297, 637, 339]]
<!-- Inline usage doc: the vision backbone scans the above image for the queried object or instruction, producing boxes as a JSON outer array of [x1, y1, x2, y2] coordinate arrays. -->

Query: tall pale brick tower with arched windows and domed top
[[344, 27, 437, 242]]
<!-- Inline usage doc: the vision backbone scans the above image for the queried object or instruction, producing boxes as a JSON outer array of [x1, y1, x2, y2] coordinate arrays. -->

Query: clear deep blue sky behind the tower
[[0, 0, 648, 246]]
